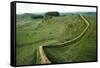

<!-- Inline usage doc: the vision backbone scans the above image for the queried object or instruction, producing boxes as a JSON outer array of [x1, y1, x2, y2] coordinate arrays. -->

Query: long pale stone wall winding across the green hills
[[39, 14, 90, 64]]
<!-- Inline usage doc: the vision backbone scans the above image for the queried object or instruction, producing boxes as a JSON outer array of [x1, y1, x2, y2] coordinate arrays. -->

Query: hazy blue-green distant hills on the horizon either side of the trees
[[16, 12, 96, 20]]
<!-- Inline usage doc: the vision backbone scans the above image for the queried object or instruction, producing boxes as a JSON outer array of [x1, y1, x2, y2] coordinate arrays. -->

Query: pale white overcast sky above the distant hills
[[16, 3, 96, 14]]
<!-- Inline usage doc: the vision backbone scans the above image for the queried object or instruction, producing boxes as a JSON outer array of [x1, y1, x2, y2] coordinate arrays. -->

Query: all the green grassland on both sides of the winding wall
[[16, 12, 96, 65]]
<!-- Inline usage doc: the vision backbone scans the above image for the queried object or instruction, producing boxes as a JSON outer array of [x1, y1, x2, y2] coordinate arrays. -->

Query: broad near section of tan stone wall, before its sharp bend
[[39, 46, 51, 64]]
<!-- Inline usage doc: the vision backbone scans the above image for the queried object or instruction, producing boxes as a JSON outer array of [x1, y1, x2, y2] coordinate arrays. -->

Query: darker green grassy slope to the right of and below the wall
[[44, 16, 96, 63]]
